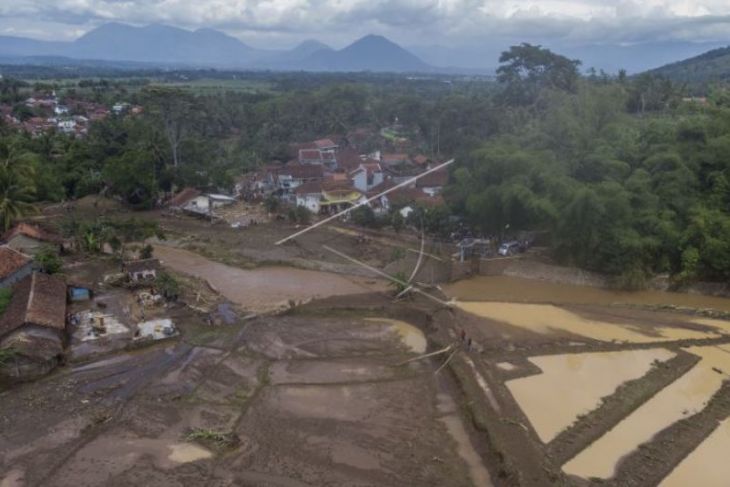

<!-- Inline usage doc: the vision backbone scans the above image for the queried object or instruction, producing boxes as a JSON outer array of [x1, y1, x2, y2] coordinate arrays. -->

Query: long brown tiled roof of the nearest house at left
[[0, 272, 66, 337]]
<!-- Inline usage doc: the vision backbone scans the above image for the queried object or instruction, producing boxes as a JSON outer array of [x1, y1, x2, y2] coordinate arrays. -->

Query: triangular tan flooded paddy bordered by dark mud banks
[[507, 348, 675, 443]]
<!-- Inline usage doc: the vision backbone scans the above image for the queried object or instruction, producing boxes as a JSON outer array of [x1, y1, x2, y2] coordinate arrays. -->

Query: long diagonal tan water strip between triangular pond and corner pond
[[563, 345, 730, 485]]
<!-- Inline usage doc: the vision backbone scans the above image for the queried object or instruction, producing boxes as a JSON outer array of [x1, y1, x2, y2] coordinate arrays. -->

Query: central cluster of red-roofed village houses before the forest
[[169, 129, 449, 221]]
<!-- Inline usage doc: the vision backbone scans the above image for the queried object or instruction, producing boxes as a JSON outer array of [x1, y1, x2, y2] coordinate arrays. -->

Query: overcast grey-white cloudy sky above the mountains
[[0, 0, 730, 47]]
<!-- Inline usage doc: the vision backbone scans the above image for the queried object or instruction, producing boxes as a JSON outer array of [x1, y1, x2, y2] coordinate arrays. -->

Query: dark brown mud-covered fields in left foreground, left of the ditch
[[0, 300, 490, 487]]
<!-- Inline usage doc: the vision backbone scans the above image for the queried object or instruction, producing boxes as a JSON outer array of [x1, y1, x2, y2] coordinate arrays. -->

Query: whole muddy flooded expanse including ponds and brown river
[[8, 208, 730, 487]]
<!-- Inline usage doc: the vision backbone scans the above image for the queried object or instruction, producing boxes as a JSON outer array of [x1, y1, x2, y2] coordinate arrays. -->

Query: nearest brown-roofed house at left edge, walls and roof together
[[0, 272, 66, 379]]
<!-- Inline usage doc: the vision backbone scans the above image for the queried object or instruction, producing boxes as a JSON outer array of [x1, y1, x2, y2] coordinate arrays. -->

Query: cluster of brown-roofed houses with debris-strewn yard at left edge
[[0, 223, 178, 380]]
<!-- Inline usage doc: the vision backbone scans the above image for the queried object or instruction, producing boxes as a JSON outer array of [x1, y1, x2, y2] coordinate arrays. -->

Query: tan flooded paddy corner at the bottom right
[[659, 419, 730, 487]]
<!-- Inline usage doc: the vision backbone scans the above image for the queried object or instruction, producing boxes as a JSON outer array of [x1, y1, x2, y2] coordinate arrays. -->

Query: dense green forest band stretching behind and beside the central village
[[0, 45, 730, 287]]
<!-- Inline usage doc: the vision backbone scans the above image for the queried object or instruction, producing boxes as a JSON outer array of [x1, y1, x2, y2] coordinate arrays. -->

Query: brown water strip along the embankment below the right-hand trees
[[444, 276, 730, 312]]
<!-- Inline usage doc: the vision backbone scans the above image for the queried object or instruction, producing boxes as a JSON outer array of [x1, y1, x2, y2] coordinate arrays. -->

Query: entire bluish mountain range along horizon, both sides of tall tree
[[0, 22, 730, 76]]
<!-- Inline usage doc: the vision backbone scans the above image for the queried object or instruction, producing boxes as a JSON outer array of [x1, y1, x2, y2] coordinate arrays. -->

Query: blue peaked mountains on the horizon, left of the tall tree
[[0, 22, 434, 72]]
